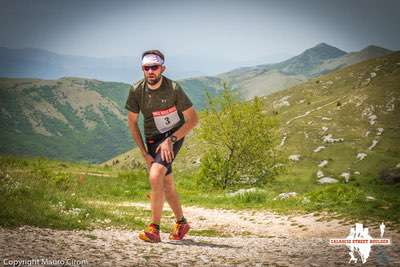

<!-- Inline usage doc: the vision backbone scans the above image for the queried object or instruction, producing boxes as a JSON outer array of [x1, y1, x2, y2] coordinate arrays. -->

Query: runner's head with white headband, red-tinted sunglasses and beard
[[142, 50, 165, 85]]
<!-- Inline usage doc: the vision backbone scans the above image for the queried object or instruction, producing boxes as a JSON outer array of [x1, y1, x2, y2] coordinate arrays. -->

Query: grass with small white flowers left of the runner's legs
[[0, 157, 149, 229]]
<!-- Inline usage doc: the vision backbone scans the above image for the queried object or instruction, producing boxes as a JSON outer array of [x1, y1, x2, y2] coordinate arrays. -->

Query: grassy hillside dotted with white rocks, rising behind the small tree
[[104, 52, 400, 183]]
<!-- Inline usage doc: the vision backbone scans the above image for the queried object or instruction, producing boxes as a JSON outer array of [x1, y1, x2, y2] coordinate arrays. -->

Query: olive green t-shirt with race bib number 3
[[125, 76, 193, 138]]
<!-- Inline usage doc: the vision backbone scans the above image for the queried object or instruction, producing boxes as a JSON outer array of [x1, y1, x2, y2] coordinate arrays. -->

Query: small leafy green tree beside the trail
[[198, 84, 280, 189]]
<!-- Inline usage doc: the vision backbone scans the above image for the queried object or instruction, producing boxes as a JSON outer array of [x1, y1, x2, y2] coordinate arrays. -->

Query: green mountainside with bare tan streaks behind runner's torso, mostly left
[[0, 77, 219, 162]]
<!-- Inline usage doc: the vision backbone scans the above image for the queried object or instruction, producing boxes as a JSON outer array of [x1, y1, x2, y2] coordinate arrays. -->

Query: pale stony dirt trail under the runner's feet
[[0, 202, 400, 266]]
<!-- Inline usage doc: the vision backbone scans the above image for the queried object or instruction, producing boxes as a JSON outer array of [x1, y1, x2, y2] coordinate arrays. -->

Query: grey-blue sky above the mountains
[[0, 0, 400, 67]]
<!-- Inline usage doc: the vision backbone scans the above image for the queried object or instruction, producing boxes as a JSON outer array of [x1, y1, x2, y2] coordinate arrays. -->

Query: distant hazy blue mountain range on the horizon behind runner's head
[[0, 47, 285, 83]]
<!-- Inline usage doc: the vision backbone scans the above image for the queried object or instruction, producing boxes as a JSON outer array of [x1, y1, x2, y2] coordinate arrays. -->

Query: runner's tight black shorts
[[146, 132, 184, 175]]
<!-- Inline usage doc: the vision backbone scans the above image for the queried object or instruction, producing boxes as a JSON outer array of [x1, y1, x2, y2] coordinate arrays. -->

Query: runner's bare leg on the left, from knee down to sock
[[149, 163, 167, 224]]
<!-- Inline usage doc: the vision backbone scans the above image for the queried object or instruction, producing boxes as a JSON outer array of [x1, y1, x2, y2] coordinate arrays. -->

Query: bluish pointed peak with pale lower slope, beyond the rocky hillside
[[217, 43, 392, 99]]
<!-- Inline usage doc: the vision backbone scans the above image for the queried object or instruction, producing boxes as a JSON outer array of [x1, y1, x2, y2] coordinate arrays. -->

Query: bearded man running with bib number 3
[[125, 50, 198, 242]]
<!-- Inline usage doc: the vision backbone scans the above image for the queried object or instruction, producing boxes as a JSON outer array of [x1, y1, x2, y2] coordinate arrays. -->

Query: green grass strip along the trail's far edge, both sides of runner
[[0, 156, 400, 236]]
